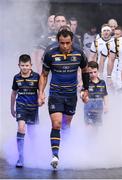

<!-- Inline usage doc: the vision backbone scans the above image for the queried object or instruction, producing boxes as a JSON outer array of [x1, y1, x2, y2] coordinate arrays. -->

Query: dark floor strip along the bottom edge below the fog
[[0, 159, 122, 179]]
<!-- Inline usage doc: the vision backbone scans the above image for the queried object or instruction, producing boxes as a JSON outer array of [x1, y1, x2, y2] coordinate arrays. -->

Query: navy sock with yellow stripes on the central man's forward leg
[[50, 129, 60, 158]]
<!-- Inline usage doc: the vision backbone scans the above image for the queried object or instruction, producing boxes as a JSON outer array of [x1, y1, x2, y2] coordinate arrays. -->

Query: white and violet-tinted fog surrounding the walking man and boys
[[0, 0, 122, 169]]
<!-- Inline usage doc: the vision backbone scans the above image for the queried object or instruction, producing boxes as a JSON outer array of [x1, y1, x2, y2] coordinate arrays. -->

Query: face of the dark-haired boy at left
[[19, 61, 32, 75]]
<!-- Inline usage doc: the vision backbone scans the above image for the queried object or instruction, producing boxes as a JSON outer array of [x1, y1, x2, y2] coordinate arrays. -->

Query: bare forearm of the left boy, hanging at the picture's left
[[11, 90, 17, 117]]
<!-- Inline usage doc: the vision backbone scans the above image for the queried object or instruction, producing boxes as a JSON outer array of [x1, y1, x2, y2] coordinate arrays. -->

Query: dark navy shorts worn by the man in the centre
[[48, 95, 77, 115]]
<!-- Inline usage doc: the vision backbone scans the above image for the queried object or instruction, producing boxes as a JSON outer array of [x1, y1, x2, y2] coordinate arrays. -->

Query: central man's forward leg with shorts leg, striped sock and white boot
[[48, 95, 64, 168]]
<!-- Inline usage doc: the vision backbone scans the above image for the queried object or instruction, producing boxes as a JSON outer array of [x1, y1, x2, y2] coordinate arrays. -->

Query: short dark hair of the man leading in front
[[57, 29, 73, 41]]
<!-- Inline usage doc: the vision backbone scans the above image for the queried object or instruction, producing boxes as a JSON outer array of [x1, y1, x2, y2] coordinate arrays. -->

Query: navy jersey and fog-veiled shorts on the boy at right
[[84, 80, 108, 124]]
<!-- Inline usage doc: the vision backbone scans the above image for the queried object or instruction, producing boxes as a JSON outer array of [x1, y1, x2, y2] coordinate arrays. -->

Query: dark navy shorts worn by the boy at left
[[16, 104, 39, 124]]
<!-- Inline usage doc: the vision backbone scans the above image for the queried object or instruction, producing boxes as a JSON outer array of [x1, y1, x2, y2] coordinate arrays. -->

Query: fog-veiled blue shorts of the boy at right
[[84, 99, 103, 124]]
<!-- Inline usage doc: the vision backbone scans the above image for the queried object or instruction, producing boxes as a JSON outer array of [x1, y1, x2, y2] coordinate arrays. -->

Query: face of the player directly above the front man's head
[[55, 16, 67, 31]]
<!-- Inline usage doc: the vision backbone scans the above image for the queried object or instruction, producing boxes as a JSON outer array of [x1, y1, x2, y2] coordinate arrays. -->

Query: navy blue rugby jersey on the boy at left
[[12, 71, 39, 109]]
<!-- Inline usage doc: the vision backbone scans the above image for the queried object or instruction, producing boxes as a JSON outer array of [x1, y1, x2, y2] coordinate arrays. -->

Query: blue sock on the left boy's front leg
[[17, 132, 25, 159]]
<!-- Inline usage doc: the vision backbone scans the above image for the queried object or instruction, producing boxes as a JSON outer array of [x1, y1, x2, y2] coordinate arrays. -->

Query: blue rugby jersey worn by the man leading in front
[[43, 47, 87, 95]]
